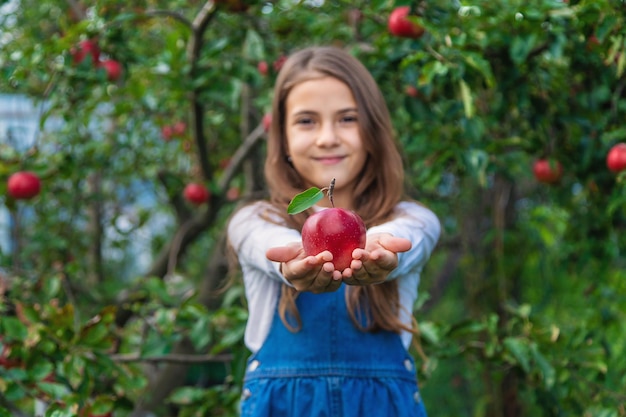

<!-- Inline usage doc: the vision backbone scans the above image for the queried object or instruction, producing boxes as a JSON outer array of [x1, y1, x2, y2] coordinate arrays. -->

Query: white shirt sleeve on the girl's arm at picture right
[[367, 201, 441, 279]]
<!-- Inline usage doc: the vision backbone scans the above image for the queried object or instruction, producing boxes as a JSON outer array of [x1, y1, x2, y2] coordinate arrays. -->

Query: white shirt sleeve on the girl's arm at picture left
[[227, 202, 302, 285]]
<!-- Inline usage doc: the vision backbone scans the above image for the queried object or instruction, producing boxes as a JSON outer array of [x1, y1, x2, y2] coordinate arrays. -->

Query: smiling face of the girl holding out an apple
[[285, 76, 367, 208]]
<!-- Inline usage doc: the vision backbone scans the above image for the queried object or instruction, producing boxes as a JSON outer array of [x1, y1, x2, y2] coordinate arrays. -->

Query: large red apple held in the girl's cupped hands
[[302, 207, 366, 271]]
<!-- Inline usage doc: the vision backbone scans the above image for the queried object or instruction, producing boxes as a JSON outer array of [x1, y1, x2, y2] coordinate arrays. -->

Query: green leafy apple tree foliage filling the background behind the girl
[[0, 0, 626, 417]]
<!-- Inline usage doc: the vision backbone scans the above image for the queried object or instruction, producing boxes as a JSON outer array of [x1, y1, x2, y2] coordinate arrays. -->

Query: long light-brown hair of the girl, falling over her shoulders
[[265, 46, 413, 332]]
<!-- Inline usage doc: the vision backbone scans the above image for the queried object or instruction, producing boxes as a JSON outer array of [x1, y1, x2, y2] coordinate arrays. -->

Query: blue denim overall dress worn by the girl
[[241, 285, 426, 417]]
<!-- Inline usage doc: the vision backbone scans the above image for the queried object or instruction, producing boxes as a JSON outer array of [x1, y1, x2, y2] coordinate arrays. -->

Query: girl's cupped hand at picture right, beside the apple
[[342, 233, 411, 285]]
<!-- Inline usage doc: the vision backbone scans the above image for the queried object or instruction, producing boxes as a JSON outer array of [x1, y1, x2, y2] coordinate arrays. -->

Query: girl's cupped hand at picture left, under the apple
[[265, 243, 342, 293]]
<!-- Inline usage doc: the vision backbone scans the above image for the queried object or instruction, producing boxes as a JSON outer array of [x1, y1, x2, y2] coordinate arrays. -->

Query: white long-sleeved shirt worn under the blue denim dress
[[228, 201, 441, 352]]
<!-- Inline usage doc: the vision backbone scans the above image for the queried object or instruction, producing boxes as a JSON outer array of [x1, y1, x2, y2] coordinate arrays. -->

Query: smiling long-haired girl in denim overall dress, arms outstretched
[[228, 47, 440, 417]]
